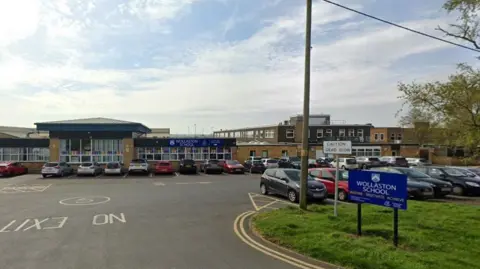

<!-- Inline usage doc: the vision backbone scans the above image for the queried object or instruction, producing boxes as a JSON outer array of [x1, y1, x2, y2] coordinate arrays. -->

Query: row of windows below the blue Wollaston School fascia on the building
[[136, 147, 232, 161]]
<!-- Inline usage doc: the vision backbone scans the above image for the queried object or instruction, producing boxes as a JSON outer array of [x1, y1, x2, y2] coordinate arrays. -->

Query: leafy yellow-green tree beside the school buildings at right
[[399, 64, 480, 156]]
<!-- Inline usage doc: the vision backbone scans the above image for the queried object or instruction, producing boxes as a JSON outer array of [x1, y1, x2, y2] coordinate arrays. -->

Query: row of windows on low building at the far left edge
[[0, 148, 50, 162]]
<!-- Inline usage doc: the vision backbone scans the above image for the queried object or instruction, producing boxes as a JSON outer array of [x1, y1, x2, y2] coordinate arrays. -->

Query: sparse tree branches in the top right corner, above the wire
[[437, 0, 480, 49]]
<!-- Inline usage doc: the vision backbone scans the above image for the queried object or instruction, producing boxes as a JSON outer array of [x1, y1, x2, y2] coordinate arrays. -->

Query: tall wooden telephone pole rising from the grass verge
[[300, 0, 312, 209]]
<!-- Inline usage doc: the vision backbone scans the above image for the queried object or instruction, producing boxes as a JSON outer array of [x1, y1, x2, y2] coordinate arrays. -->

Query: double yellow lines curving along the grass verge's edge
[[233, 211, 326, 269]]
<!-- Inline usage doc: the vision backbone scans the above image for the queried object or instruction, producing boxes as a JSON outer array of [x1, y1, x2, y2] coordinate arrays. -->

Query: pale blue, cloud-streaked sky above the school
[[0, 0, 478, 134]]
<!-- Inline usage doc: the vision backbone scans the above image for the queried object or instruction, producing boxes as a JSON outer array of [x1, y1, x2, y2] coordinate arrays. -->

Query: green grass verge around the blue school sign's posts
[[253, 201, 480, 269]]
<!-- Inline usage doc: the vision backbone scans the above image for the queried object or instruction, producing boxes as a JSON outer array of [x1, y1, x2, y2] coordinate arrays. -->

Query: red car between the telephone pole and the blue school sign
[[308, 168, 349, 201]]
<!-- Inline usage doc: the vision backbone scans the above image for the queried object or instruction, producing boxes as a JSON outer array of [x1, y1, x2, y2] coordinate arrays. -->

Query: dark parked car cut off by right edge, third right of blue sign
[[415, 166, 480, 195]]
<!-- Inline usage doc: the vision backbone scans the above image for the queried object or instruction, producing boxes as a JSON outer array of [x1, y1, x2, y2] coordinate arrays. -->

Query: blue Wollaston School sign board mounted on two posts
[[348, 170, 408, 210]]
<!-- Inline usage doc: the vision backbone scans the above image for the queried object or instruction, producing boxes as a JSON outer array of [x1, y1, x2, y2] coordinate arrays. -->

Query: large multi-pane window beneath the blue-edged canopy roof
[[60, 139, 123, 163]]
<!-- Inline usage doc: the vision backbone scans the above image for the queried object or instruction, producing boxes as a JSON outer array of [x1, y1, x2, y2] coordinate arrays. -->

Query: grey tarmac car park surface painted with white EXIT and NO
[[0, 174, 312, 269]]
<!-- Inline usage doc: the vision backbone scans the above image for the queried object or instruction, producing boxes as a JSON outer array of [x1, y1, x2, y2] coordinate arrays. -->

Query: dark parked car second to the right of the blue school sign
[[376, 167, 453, 198]]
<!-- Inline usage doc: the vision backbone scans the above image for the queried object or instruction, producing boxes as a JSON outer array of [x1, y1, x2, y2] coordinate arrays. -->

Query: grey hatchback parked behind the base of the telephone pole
[[260, 168, 327, 203]]
